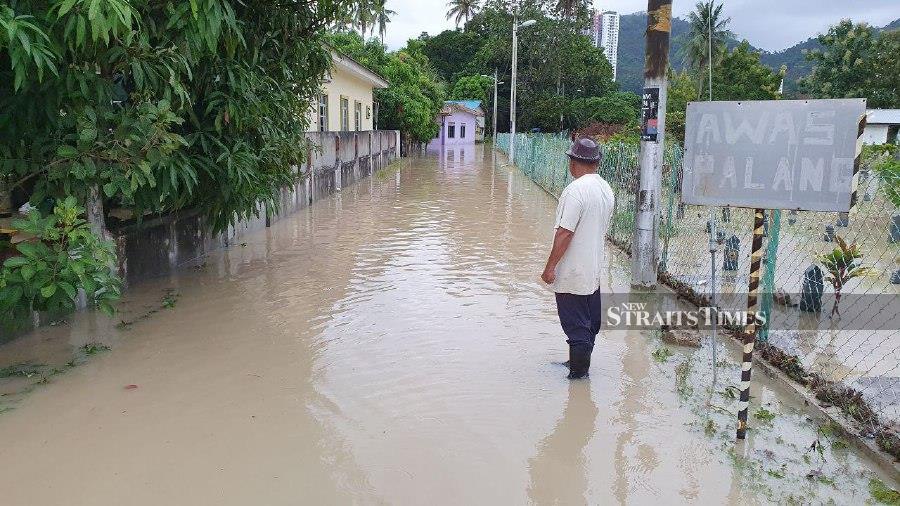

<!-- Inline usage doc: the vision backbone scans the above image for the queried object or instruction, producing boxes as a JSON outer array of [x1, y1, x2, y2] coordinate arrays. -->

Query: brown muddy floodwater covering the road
[[0, 147, 896, 505]]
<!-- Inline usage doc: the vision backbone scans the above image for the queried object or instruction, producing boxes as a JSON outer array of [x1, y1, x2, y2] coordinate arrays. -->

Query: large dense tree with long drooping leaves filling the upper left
[[0, 0, 356, 316]]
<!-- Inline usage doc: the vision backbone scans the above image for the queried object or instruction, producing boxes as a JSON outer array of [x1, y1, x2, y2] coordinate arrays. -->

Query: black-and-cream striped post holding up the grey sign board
[[737, 209, 765, 439]]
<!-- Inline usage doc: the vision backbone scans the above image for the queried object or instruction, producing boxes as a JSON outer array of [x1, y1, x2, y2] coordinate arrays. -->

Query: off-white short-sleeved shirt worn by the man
[[550, 174, 615, 295]]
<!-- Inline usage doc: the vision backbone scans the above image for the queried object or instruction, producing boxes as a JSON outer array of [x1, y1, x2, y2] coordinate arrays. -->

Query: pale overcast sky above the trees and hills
[[385, 0, 900, 51]]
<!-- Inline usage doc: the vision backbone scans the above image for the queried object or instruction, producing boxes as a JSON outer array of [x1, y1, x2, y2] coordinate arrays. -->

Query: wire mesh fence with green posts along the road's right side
[[496, 134, 900, 457]]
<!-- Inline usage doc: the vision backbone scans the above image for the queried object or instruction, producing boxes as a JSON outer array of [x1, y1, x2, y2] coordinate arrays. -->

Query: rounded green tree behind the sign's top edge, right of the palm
[[713, 40, 783, 100]]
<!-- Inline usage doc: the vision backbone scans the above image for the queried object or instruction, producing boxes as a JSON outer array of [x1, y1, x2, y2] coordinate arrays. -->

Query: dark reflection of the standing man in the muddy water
[[528, 381, 599, 504]]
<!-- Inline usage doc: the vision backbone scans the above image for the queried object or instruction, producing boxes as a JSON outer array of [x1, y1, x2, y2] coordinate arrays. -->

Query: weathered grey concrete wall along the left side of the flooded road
[[113, 130, 400, 284]]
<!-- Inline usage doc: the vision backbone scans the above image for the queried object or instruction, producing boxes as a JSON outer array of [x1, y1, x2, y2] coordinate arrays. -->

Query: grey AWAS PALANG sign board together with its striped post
[[681, 99, 866, 440]]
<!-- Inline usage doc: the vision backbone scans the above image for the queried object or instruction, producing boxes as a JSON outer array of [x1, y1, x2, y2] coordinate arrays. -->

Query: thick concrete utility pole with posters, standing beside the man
[[631, 0, 672, 288]]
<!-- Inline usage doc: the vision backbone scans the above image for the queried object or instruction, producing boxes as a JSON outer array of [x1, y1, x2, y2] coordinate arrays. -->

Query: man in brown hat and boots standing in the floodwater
[[541, 139, 615, 379]]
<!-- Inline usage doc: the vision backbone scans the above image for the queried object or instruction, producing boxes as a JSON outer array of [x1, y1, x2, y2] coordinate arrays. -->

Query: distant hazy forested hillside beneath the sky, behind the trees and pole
[[616, 12, 900, 93]]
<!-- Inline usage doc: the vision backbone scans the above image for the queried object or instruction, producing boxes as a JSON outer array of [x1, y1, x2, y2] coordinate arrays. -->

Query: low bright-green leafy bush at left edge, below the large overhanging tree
[[0, 197, 121, 322]]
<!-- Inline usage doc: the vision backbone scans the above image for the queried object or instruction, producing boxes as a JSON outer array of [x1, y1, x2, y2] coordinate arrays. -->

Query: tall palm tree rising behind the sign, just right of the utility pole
[[682, 0, 733, 97]]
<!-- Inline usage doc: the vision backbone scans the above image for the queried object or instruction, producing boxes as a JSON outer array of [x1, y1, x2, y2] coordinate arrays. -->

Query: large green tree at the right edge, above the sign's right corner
[[800, 20, 900, 107]]
